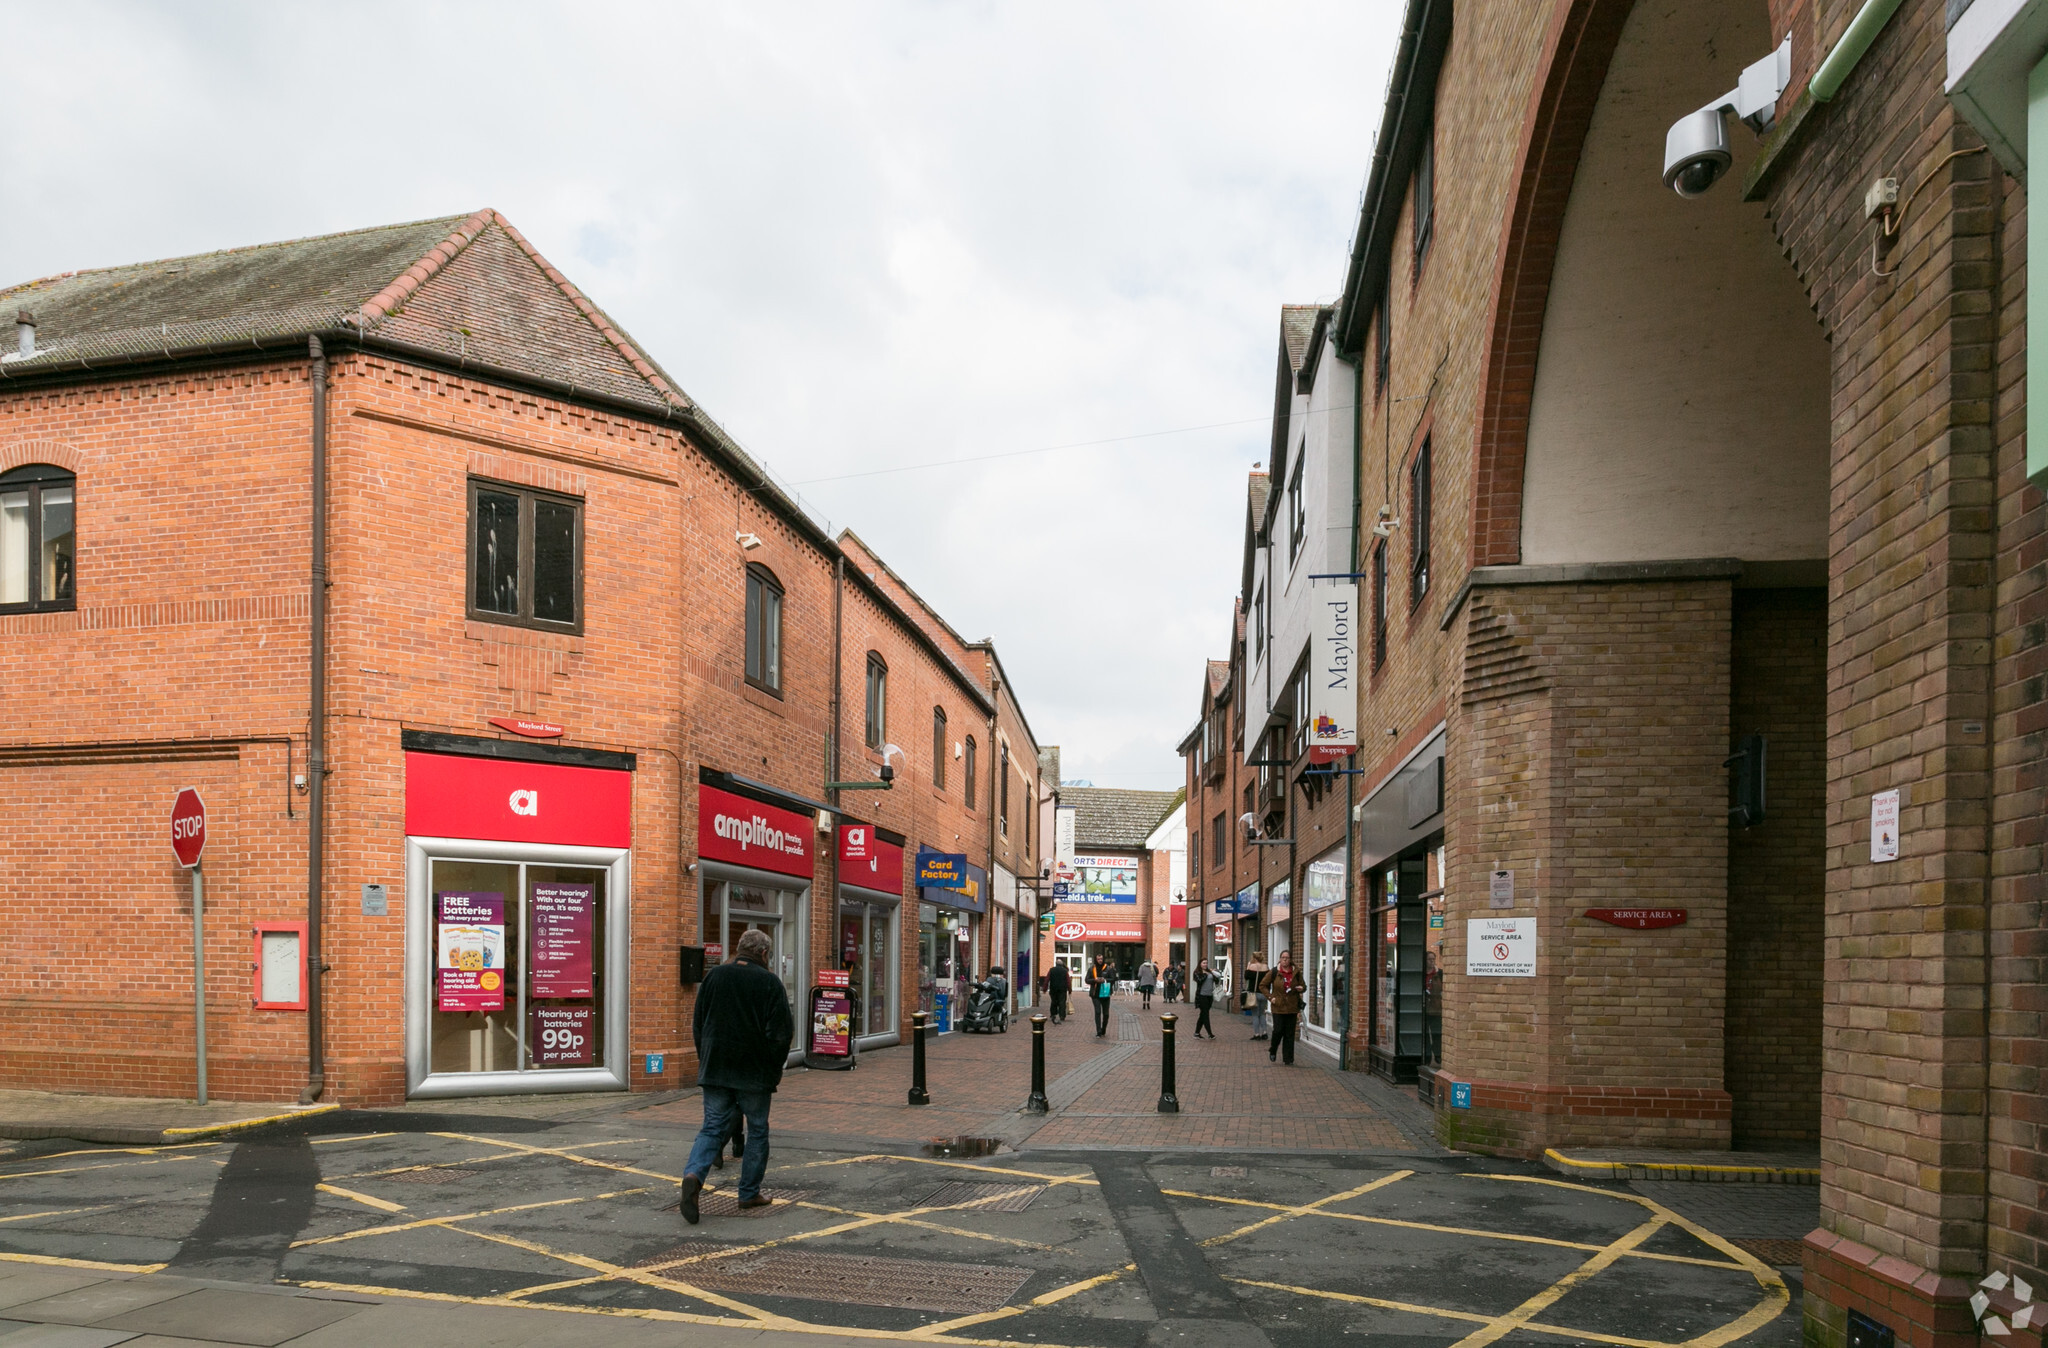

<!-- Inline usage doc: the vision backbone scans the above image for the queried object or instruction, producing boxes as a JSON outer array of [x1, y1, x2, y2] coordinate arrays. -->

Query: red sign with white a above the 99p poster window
[[406, 754, 633, 848]]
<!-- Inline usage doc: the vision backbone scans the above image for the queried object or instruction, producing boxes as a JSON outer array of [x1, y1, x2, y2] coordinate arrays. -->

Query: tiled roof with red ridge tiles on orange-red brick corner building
[[0, 209, 694, 414]]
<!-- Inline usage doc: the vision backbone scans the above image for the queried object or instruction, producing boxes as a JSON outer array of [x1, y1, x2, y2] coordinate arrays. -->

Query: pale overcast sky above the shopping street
[[0, 0, 1401, 789]]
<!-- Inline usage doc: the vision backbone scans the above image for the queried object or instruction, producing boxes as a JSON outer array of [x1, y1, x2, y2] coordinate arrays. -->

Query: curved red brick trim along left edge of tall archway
[[1473, 0, 1634, 565]]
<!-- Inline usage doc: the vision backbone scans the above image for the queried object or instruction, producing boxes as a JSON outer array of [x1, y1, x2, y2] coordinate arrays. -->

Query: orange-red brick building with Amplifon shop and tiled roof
[[0, 211, 1040, 1104]]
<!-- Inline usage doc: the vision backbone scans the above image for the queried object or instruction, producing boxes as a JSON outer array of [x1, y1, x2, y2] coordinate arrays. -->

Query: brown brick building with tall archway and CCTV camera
[[1184, 0, 2048, 1344]]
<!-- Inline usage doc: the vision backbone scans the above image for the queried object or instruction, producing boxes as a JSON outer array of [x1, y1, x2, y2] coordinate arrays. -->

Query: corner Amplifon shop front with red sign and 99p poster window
[[401, 731, 635, 1098]]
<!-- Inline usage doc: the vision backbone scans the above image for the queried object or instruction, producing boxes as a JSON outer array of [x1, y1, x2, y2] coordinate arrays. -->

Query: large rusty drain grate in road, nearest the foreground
[[635, 1241, 1030, 1315]]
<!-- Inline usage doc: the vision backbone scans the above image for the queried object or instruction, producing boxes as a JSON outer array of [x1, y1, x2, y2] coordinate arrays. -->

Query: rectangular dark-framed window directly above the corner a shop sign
[[469, 479, 584, 631]]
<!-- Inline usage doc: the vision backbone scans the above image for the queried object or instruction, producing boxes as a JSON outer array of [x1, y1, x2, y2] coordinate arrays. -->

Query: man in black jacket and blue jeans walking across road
[[682, 930, 797, 1227]]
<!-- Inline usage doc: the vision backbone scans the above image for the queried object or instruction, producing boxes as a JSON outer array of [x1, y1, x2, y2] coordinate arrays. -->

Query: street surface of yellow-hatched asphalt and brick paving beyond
[[0, 991, 1810, 1348]]
